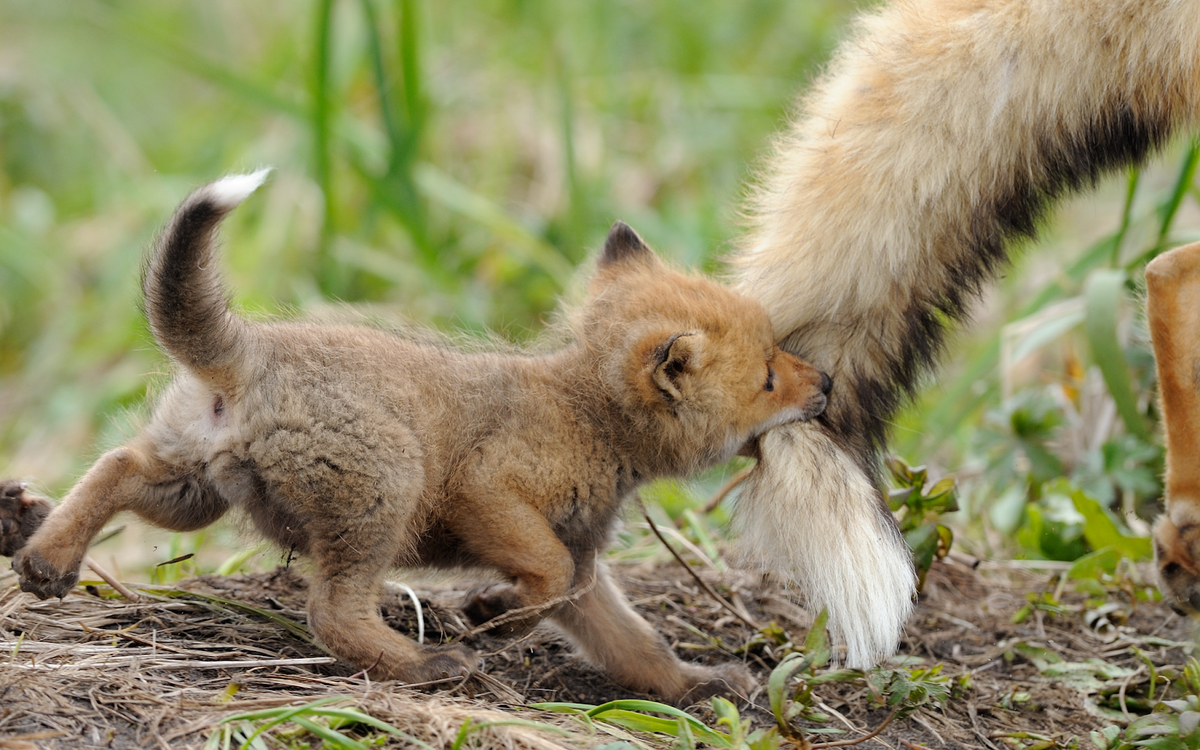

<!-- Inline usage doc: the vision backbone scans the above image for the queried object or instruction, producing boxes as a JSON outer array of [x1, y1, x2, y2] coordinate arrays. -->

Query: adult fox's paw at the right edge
[[1154, 506, 1200, 617]]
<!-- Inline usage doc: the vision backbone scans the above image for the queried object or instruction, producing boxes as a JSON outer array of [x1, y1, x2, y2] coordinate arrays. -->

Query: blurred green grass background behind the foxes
[[0, 0, 1200, 578]]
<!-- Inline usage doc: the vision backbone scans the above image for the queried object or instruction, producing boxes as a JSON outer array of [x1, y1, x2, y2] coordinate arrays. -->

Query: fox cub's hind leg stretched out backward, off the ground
[[12, 442, 228, 599]]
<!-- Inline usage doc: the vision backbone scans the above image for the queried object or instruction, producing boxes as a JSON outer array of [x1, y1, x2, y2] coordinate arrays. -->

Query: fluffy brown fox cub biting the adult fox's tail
[[0, 170, 829, 701]]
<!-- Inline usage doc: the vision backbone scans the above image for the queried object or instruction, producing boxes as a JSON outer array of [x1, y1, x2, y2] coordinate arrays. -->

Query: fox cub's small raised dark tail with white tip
[[142, 169, 270, 378]]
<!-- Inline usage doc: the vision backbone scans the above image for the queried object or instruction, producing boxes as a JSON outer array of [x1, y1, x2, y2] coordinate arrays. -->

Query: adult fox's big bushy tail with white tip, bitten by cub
[[732, 0, 1200, 665]]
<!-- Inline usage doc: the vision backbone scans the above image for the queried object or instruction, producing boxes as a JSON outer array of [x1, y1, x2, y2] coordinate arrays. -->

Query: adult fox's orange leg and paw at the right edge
[[1146, 242, 1200, 614]]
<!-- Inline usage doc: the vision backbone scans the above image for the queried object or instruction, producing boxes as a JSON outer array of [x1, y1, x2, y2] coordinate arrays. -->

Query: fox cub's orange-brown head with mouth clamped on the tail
[[578, 222, 830, 469]]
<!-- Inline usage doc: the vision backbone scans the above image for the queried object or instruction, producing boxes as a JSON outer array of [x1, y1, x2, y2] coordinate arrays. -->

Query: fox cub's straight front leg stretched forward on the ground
[[553, 559, 755, 704]]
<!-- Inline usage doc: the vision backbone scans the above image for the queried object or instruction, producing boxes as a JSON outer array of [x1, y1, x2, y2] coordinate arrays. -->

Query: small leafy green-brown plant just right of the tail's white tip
[[888, 457, 959, 589]]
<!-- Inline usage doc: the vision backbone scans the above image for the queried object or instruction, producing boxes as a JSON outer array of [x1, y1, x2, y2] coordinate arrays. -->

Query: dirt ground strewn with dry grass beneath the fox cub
[[0, 552, 1194, 749]]
